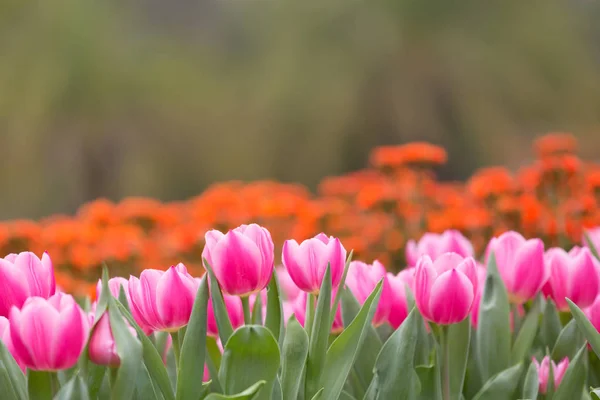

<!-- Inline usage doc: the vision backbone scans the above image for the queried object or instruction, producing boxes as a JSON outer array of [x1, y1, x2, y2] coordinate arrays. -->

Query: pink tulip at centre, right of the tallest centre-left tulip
[[282, 233, 346, 294]]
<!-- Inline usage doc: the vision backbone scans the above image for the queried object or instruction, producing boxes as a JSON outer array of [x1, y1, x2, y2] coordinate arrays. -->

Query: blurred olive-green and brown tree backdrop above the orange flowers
[[0, 0, 600, 219]]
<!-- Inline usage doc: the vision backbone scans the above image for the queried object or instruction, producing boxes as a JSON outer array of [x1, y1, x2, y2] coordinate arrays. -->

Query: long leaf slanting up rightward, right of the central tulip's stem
[[321, 280, 383, 400]]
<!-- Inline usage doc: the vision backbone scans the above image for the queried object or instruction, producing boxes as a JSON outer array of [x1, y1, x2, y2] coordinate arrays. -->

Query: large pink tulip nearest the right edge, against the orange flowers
[[543, 248, 599, 311]]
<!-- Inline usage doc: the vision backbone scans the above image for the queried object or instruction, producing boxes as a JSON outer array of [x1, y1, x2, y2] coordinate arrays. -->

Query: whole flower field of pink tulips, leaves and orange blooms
[[0, 133, 600, 400]]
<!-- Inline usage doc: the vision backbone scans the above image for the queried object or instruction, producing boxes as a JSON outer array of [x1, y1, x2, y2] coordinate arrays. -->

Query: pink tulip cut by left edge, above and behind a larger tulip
[[0, 251, 56, 317]]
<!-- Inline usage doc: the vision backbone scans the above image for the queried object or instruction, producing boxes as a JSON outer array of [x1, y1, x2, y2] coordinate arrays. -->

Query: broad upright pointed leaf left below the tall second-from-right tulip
[[476, 254, 511, 381]]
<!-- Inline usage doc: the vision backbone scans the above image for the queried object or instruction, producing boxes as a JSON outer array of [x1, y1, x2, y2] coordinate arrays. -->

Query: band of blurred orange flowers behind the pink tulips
[[0, 133, 600, 294]]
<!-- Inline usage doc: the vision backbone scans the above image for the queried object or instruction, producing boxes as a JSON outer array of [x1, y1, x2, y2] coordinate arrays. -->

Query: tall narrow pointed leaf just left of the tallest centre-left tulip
[[175, 275, 208, 400]]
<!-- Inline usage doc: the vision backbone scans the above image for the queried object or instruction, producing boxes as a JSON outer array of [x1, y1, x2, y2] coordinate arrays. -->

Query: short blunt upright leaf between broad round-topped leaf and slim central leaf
[[281, 315, 308, 399]]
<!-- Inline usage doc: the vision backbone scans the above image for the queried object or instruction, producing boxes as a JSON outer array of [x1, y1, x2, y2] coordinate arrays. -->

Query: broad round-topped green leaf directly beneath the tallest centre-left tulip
[[219, 325, 280, 400]]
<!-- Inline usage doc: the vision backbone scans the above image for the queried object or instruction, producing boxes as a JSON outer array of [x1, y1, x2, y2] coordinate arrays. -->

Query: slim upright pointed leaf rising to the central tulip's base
[[304, 265, 331, 397]]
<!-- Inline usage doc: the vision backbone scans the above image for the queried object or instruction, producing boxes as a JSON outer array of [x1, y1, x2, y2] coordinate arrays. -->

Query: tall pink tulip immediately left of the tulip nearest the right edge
[[487, 231, 550, 304]]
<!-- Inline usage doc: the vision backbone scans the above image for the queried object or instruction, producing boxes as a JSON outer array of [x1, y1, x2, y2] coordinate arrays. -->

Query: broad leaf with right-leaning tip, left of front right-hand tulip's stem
[[374, 309, 423, 399]]
